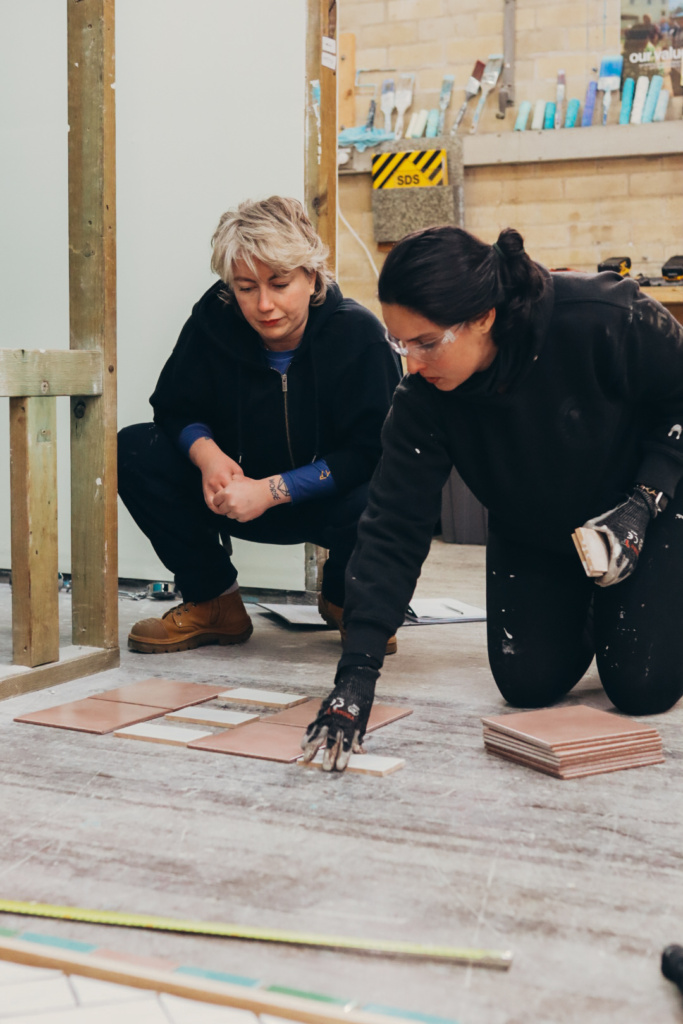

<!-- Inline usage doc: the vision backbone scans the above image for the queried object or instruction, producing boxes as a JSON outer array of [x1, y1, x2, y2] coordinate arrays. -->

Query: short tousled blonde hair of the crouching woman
[[211, 196, 333, 305]]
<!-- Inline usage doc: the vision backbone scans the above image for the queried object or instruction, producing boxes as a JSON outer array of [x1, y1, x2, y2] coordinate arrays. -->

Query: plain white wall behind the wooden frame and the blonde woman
[[0, 0, 305, 589]]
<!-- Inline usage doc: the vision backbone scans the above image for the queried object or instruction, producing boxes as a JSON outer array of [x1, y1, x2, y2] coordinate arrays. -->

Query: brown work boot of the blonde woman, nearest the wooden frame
[[128, 590, 254, 654]]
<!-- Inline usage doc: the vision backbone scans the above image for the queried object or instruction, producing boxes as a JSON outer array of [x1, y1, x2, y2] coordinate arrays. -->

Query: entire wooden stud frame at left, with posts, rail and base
[[0, 0, 119, 698]]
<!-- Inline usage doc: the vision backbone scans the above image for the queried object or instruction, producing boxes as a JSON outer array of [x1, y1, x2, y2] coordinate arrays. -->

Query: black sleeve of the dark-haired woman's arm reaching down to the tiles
[[342, 379, 452, 665]]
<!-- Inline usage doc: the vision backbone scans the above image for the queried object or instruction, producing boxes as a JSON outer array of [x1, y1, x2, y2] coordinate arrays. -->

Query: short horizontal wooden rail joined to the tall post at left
[[0, 348, 102, 397]]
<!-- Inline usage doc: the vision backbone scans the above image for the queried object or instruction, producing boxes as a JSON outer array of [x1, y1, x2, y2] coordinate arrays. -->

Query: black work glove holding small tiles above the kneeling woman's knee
[[584, 487, 657, 587]]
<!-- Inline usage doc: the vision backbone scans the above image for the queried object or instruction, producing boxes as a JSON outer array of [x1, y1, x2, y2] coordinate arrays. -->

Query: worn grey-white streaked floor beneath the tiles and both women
[[0, 540, 683, 1024]]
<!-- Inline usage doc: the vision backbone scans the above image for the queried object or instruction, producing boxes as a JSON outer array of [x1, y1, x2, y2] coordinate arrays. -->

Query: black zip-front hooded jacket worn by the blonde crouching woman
[[150, 282, 399, 494]]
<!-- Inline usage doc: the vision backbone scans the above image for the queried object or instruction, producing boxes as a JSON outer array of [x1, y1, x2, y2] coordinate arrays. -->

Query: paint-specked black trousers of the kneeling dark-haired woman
[[486, 486, 683, 715]]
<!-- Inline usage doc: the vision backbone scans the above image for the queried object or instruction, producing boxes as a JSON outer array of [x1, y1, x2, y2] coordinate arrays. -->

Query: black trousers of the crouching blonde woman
[[119, 423, 368, 607]]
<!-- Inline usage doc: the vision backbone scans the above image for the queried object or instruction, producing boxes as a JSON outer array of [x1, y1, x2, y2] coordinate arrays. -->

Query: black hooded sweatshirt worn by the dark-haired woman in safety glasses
[[345, 272, 683, 663]]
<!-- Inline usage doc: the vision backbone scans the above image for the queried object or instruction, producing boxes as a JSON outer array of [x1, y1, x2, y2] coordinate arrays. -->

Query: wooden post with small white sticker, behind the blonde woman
[[304, 0, 339, 591]]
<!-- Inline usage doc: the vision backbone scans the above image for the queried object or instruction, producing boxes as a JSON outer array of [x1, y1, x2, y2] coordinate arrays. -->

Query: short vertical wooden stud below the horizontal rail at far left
[[9, 397, 59, 667]]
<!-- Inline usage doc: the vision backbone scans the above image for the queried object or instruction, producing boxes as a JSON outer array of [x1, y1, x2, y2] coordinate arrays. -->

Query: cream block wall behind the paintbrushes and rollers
[[339, 0, 683, 310]]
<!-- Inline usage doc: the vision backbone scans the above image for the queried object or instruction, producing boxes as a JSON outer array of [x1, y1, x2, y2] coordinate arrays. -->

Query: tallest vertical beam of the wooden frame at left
[[67, 0, 118, 647]]
